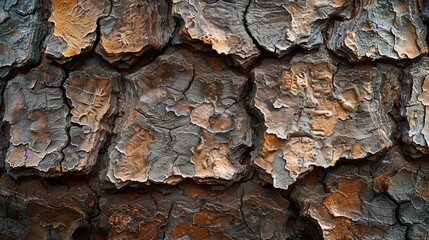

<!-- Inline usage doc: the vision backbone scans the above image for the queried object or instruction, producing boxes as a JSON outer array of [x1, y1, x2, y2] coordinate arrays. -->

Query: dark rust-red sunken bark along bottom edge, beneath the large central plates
[[100, 181, 291, 239]]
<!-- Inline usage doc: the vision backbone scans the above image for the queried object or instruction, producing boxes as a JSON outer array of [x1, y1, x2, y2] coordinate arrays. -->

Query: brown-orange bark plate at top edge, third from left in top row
[[96, 0, 174, 65]]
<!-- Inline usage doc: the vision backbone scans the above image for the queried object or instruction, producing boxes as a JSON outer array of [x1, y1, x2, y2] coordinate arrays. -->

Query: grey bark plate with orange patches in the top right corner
[[327, 0, 428, 62]]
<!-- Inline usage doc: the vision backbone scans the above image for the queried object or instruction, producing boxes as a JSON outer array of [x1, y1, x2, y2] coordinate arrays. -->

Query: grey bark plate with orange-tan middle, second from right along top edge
[[246, 0, 353, 57]]
